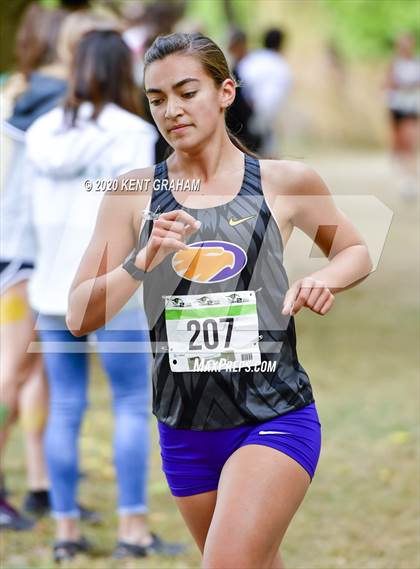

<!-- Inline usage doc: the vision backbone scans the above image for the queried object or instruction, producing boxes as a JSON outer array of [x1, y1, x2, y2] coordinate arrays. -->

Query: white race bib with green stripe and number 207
[[165, 291, 261, 372]]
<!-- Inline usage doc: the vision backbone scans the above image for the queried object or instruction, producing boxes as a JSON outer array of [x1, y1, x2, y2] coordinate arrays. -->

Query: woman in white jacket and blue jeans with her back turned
[[27, 30, 184, 560]]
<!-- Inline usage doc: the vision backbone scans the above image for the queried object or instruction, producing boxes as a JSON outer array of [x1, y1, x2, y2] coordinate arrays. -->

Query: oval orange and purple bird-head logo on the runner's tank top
[[172, 241, 247, 283]]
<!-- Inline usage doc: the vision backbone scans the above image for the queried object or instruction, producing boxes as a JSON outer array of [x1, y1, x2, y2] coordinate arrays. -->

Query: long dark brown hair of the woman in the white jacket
[[64, 30, 141, 126]]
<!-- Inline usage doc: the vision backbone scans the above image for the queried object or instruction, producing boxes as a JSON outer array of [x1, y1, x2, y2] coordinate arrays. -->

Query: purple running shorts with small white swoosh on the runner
[[158, 403, 321, 497]]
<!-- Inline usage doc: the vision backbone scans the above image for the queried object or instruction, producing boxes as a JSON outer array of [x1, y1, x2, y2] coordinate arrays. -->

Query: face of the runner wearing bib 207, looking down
[[145, 55, 231, 151]]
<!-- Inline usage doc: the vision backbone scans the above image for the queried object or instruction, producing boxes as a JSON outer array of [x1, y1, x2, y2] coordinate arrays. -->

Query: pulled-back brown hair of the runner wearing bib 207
[[144, 33, 256, 157]]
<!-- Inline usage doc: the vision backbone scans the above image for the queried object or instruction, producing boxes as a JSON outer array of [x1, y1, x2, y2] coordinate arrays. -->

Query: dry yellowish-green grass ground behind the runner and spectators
[[1, 149, 420, 569]]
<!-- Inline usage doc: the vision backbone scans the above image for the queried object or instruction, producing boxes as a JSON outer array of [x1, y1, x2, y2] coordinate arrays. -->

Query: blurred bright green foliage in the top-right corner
[[321, 0, 420, 59]]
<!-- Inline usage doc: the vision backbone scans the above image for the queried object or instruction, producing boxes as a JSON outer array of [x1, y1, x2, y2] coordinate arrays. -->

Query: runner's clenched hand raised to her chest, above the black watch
[[137, 209, 201, 271]]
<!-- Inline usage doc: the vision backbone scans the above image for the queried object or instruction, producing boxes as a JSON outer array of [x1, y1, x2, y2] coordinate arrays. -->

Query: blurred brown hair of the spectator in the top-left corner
[[15, 2, 67, 76]]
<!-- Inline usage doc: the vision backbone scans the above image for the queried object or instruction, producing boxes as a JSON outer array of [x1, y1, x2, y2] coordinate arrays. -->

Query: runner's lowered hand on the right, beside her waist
[[282, 277, 335, 316]]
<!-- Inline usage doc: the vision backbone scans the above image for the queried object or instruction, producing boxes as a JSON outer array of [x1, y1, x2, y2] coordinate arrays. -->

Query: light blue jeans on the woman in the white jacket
[[37, 310, 150, 518]]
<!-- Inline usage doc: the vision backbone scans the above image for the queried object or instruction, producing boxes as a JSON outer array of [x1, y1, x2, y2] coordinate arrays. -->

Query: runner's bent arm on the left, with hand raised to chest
[[66, 171, 198, 336]]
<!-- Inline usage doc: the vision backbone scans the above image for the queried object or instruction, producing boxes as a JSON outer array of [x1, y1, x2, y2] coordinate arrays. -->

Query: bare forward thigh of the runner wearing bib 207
[[203, 445, 310, 569]]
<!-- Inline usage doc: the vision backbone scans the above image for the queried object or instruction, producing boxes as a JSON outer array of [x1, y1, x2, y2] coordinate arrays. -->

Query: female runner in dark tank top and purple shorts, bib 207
[[67, 34, 372, 569]]
